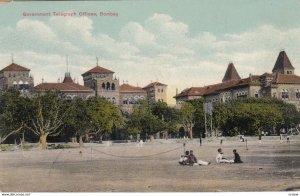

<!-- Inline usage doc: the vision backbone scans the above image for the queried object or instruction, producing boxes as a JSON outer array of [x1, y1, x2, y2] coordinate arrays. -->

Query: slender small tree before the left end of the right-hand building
[[180, 102, 196, 139]]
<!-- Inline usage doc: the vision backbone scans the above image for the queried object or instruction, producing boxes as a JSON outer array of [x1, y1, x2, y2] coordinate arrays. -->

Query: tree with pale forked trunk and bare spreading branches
[[28, 92, 69, 149]]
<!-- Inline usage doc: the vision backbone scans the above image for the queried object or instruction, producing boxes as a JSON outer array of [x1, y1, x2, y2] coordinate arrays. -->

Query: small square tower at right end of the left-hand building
[[143, 82, 168, 102]]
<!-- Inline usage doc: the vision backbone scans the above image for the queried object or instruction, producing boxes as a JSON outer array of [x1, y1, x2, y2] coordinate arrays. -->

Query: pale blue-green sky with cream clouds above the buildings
[[0, 0, 300, 104]]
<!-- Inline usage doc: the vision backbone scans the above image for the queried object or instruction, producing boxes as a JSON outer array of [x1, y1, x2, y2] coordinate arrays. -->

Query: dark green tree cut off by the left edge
[[0, 89, 30, 144]]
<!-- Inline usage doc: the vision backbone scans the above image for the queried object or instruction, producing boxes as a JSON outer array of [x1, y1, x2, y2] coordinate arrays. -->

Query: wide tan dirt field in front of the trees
[[0, 136, 300, 192]]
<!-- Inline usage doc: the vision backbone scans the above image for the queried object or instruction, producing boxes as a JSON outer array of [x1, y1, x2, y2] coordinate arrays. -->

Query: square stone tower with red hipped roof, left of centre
[[82, 59, 120, 105]]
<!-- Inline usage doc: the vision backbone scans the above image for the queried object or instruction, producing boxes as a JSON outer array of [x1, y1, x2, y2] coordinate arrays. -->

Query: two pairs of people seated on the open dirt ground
[[179, 148, 243, 166]]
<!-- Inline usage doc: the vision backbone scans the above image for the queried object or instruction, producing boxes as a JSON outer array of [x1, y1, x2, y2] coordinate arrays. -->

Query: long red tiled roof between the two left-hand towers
[[34, 83, 94, 93]]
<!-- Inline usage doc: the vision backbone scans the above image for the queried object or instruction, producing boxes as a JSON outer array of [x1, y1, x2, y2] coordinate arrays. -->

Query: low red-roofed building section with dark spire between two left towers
[[34, 72, 95, 99]]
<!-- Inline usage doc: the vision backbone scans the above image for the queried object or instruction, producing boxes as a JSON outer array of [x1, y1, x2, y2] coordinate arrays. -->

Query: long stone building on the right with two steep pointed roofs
[[174, 51, 300, 109]]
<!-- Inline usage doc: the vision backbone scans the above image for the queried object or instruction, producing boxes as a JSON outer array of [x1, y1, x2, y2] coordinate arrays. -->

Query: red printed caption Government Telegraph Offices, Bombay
[[23, 12, 119, 17]]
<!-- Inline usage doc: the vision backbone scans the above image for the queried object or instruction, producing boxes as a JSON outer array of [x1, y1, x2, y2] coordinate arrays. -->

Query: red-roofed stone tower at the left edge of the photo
[[0, 63, 34, 91]]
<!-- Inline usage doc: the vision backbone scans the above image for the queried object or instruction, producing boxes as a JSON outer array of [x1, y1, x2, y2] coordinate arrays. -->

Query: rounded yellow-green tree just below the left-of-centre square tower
[[87, 97, 125, 142]]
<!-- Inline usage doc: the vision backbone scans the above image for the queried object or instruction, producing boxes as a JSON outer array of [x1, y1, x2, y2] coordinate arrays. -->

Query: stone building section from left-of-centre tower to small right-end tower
[[82, 65, 167, 108]]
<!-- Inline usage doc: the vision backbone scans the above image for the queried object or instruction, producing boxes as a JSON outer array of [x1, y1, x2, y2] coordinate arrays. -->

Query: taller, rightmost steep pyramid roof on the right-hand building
[[272, 50, 295, 74]]
